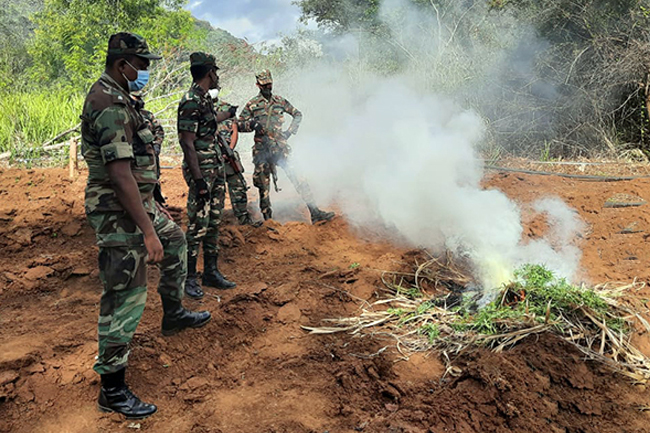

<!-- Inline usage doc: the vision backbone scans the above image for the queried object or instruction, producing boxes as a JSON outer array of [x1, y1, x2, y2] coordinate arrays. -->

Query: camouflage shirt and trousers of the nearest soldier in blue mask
[[81, 67, 187, 374]]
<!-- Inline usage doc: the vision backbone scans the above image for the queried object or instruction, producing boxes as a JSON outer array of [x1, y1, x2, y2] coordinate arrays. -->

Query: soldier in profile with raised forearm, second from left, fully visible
[[177, 52, 242, 299]]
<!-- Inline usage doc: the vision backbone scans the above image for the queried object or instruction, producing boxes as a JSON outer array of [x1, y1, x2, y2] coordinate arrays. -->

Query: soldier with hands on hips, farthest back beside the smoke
[[239, 69, 334, 223]]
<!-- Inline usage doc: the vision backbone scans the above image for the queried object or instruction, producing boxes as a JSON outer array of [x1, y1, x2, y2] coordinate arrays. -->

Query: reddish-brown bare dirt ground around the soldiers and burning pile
[[0, 169, 650, 433]]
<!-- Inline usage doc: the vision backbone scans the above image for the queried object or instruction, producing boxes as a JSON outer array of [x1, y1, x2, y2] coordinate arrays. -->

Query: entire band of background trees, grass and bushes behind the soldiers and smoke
[[0, 0, 650, 162]]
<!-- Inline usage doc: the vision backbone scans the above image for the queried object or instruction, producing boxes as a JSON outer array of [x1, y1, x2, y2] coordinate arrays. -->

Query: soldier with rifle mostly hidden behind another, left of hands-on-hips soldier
[[217, 100, 261, 226]]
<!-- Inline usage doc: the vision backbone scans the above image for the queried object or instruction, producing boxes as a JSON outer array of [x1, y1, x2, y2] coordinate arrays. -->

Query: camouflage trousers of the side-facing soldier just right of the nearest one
[[183, 165, 226, 257]]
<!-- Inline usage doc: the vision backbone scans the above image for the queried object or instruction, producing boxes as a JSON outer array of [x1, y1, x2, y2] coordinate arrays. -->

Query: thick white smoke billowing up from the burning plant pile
[[260, 0, 581, 289]]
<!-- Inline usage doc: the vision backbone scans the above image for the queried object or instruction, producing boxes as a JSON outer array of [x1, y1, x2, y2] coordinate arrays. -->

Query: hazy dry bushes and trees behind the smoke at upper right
[[297, 0, 650, 158]]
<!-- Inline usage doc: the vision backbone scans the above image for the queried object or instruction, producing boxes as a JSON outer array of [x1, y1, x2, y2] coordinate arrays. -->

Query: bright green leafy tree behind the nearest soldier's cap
[[28, 0, 194, 88]]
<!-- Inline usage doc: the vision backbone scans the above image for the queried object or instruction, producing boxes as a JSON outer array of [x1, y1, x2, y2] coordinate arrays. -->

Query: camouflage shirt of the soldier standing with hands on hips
[[239, 93, 302, 141]]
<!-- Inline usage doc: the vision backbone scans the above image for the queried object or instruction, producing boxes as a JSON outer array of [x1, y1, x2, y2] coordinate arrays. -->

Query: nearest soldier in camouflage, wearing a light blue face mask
[[81, 33, 210, 418]]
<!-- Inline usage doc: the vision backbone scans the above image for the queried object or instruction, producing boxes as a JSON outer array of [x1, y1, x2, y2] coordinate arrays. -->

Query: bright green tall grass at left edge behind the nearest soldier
[[0, 89, 85, 158]]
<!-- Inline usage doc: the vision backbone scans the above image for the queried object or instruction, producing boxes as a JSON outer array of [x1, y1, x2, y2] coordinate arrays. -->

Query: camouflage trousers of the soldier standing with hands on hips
[[253, 144, 314, 219]]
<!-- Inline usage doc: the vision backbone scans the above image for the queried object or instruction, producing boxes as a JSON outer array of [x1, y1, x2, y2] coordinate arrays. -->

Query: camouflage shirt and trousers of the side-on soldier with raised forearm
[[178, 76, 226, 257]]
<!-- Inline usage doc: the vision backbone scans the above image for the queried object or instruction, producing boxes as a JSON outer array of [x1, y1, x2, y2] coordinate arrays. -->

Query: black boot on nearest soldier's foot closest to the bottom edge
[[97, 368, 158, 419]]
